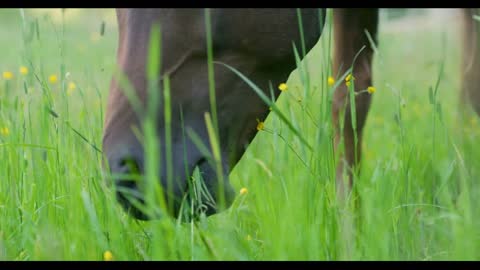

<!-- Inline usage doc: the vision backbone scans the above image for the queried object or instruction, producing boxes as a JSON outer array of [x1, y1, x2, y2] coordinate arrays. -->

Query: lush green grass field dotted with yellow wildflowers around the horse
[[0, 9, 480, 260]]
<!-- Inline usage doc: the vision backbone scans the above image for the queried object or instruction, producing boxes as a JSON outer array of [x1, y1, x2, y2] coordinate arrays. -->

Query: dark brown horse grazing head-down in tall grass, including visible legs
[[103, 9, 480, 218]]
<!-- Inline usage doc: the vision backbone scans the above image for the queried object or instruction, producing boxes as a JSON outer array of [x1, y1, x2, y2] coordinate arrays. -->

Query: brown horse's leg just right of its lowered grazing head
[[333, 9, 378, 198]]
